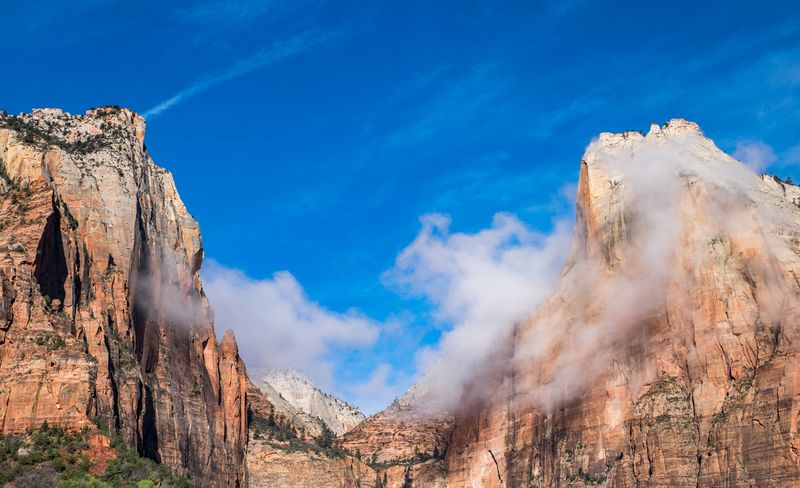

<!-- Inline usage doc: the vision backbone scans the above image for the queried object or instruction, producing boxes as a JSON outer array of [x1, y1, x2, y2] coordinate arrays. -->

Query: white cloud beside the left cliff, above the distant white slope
[[202, 260, 379, 390]]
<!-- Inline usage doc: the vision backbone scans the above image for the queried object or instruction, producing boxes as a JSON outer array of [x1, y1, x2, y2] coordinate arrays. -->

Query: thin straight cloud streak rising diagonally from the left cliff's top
[[143, 31, 337, 119]]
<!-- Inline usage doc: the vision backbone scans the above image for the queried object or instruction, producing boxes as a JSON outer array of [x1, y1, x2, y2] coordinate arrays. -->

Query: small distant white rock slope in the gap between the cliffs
[[259, 369, 365, 436]]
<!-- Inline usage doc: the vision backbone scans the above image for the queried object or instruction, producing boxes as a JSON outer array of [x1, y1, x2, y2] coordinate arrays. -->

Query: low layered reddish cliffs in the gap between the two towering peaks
[[246, 368, 452, 488]]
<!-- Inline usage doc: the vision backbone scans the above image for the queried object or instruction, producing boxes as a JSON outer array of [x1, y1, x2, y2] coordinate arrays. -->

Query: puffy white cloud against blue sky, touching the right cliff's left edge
[[384, 213, 571, 409]]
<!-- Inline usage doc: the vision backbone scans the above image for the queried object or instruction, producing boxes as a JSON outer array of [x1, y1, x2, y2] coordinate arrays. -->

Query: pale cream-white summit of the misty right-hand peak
[[574, 119, 771, 265]]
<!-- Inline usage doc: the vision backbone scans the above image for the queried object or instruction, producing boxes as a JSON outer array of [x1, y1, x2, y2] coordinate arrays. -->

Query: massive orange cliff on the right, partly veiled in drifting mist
[[446, 120, 800, 487]]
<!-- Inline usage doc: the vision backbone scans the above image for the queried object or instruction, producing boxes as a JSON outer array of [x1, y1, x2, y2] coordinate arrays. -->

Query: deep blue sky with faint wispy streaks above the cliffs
[[0, 0, 800, 411]]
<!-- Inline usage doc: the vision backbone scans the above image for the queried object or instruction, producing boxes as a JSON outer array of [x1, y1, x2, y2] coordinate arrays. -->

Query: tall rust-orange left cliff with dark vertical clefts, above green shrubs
[[0, 108, 247, 487]]
